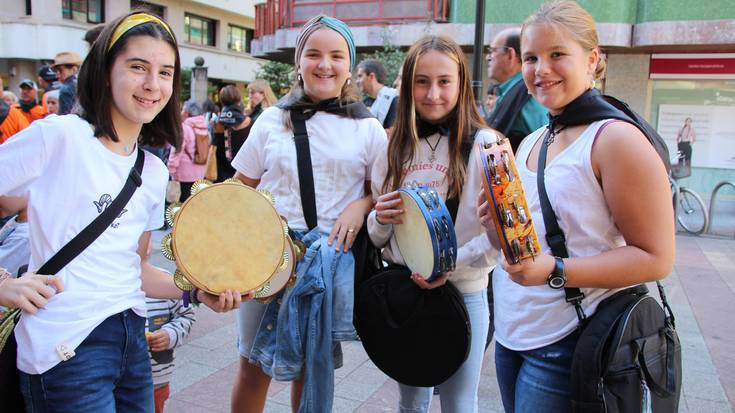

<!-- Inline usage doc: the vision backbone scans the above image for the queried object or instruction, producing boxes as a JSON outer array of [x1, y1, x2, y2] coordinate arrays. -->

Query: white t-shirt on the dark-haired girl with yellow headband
[[0, 115, 168, 374]]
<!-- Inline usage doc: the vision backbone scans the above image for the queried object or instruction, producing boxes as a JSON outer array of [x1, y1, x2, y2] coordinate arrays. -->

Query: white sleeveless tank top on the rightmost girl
[[493, 120, 625, 351]]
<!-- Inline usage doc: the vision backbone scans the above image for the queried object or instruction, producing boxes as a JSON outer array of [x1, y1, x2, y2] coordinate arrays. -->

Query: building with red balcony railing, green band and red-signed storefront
[[253, 0, 735, 194]]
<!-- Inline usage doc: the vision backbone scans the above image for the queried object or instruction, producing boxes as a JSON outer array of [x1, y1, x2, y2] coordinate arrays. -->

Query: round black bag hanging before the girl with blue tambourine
[[355, 265, 471, 387]]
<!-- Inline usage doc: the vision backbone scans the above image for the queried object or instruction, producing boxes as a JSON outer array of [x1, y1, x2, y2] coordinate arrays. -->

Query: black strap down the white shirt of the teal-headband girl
[[290, 109, 317, 230]]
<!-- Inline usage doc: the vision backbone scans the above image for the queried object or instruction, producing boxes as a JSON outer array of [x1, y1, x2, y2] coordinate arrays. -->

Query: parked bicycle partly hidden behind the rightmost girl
[[669, 151, 709, 235]]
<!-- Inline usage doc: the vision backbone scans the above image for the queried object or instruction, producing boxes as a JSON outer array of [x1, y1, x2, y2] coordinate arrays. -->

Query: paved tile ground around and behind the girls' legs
[[148, 232, 735, 413]]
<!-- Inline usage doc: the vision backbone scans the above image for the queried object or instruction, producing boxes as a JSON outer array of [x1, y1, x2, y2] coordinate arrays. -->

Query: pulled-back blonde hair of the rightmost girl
[[521, 0, 606, 80]]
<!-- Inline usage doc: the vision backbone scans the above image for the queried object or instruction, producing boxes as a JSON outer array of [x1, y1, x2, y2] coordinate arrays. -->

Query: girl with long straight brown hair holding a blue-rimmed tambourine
[[368, 36, 497, 412]]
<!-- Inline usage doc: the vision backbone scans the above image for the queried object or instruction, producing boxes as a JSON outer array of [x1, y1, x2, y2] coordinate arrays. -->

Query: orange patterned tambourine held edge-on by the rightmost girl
[[477, 138, 541, 264]]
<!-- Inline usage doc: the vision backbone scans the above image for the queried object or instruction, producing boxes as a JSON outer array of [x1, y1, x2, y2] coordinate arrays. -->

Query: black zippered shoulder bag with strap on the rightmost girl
[[536, 120, 681, 413]]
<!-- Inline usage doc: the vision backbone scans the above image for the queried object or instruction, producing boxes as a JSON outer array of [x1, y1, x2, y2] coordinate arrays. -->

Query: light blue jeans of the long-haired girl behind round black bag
[[398, 290, 489, 413]]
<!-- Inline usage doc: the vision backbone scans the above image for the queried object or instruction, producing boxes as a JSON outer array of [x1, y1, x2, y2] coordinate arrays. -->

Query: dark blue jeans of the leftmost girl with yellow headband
[[20, 310, 153, 413]]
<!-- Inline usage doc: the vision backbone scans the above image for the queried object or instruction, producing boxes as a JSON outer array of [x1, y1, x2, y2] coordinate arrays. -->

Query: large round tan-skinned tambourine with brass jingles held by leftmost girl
[[162, 180, 301, 300]]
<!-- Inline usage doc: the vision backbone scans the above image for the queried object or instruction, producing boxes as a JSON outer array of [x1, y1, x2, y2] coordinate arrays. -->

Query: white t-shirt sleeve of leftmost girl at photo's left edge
[[0, 120, 52, 198]]
